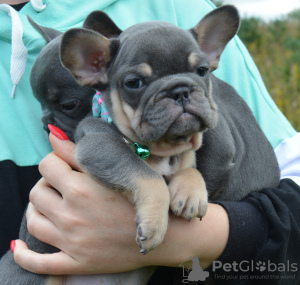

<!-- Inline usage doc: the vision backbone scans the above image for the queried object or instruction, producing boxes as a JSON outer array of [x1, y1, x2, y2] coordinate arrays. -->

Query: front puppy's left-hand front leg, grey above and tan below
[[76, 118, 170, 253]]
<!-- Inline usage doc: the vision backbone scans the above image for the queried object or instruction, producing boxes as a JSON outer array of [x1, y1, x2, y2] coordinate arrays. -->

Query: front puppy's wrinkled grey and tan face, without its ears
[[107, 22, 217, 153]]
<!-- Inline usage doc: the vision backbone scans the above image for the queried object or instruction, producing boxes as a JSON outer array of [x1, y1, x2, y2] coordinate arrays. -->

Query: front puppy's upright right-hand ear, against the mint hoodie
[[190, 5, 240, 70]]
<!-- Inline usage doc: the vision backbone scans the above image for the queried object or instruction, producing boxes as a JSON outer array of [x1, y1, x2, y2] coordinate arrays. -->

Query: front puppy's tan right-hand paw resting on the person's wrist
[[169, 168, 208, 221]]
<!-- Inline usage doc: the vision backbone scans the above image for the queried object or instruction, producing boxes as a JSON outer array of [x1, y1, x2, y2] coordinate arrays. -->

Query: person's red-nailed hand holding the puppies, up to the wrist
[[14, 135, 148, 274]]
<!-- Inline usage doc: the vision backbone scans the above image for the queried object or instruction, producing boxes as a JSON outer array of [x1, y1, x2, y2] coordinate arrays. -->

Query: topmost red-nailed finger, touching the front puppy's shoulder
[[49, 133, 82, 171]]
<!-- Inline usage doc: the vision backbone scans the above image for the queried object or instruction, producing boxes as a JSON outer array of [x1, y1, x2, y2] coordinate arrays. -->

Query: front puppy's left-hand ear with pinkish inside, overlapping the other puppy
[[60, 29, 119, 90]]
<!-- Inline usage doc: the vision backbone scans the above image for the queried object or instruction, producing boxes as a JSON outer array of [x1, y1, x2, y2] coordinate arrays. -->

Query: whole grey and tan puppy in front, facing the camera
[[0, 6, 279, 284]]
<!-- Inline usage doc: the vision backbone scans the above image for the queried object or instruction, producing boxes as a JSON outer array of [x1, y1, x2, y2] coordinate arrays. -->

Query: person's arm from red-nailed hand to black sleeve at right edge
[[14, 136, 300, 284]]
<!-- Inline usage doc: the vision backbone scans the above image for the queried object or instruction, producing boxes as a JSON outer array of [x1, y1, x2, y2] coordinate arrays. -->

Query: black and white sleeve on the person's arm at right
[[206, 133, 300, 280]]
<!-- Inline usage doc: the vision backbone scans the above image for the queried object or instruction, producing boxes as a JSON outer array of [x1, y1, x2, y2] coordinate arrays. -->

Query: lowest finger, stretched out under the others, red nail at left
[[14, 240, 81, 275]]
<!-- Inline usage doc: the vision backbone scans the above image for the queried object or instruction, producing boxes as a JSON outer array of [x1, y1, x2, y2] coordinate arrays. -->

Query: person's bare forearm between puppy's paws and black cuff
[[145, 204, 229, 268]]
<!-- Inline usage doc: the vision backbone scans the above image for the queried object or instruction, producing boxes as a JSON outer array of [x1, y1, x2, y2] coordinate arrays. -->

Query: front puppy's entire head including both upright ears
[[61, 6, 239, 153]]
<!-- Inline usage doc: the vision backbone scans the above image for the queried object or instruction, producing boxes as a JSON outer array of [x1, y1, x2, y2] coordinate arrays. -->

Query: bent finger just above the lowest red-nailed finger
[[26, 203, 61, 247]]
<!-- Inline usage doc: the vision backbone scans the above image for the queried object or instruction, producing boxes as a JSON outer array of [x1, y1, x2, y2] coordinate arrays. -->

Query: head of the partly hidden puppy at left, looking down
[[28, 17, 95, 141]]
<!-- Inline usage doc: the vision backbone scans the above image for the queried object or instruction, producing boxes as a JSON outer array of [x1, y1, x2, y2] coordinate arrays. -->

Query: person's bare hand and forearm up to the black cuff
[[14, 135, 229, 275]]
